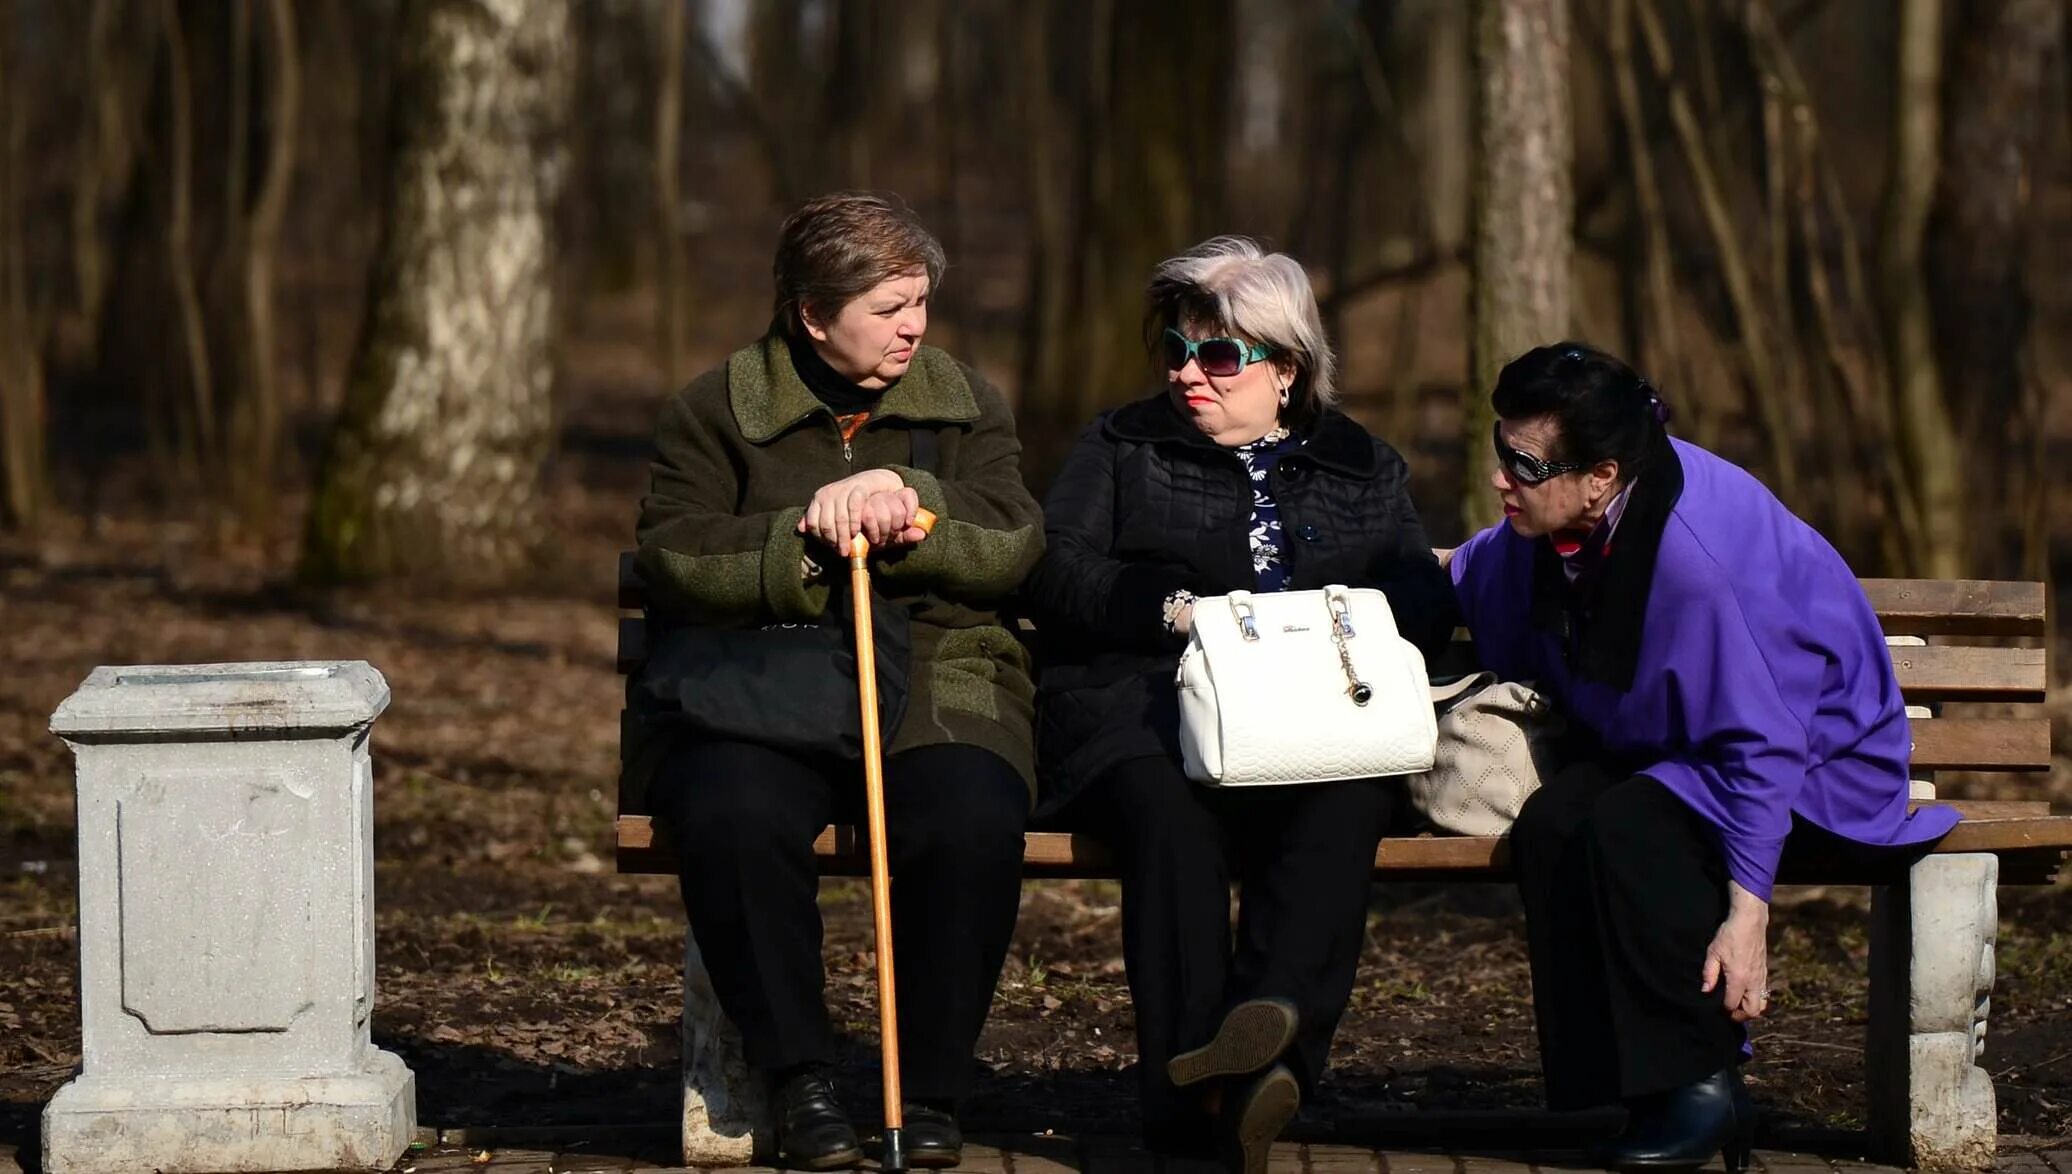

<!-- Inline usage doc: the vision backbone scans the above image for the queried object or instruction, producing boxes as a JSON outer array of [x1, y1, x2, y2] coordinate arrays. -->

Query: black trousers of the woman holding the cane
[[651, 741, 1028, 1102]]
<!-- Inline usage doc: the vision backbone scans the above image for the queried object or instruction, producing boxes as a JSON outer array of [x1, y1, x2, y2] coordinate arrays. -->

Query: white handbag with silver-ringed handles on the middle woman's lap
[[1177, 586, 1438, 787]]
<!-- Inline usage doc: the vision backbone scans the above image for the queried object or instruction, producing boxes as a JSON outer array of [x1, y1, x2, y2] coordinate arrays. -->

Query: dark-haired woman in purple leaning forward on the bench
[[1446, 344, 1956, 1170]]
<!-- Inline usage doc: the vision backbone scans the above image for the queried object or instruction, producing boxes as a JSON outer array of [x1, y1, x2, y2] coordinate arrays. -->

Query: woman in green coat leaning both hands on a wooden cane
[[636, 193, 1042, 1170]]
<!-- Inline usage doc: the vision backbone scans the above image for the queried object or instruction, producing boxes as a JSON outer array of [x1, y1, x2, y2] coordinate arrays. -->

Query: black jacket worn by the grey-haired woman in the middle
[[1024, 393, 1457, 814]]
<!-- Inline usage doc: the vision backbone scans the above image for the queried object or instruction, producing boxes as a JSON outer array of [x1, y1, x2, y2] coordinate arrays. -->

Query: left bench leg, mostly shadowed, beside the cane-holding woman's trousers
[[684, 930, 777, 1166]]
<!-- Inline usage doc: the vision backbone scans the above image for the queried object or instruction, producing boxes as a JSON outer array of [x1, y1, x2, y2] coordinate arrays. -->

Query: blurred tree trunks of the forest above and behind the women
[[0, 0, 2072, 580]]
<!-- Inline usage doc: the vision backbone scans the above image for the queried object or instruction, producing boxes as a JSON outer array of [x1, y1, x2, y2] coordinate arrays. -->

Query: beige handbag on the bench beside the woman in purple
[[1409, 673, 1564, 837]]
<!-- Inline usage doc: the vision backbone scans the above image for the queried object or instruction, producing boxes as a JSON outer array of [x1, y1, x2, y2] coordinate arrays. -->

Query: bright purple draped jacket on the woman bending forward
[[1452, 441, 1958, 901]]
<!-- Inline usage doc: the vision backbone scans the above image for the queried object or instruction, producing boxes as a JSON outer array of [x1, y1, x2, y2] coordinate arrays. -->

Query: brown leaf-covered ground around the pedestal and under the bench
[[0, 323, 2072, 1145]]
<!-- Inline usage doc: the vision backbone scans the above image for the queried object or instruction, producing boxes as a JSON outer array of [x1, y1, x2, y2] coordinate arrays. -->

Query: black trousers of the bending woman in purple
[[1510, 760, 1919, 1110]]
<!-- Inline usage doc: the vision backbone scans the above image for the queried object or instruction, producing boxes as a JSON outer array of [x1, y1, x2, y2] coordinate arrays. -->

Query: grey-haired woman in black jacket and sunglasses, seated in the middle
[[1024, 236, 1455, 1170]]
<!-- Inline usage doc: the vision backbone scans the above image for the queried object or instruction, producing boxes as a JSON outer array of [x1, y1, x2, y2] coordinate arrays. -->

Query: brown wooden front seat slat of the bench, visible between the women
[[617, 799, 2072, 880]]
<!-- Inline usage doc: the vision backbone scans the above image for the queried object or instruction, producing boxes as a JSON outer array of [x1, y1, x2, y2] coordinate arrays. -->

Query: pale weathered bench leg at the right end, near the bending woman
[[1867, 853, 1999, 1170]]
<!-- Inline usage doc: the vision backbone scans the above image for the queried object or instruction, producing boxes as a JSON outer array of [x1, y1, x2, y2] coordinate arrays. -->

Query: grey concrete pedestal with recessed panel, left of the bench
[[44, 661, 416, 1174]]
